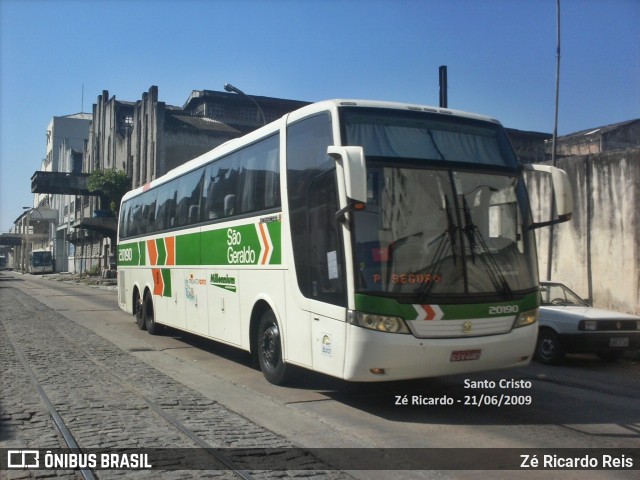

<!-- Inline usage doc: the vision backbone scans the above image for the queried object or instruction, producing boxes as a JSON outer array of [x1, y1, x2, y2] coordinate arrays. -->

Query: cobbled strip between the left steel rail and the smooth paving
[[0, 289, 348, 480]]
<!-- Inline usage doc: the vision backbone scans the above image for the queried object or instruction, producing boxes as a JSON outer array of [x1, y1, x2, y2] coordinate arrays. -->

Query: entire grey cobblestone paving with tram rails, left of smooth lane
[[0, 276, 346, 478]]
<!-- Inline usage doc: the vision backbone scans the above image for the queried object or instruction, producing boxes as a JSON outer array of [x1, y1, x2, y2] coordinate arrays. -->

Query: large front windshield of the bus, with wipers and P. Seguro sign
[[343, 112, 537, 303]]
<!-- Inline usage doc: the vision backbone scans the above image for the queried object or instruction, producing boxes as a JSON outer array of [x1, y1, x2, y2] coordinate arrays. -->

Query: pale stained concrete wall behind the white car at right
[[529, 149, 640, 315]]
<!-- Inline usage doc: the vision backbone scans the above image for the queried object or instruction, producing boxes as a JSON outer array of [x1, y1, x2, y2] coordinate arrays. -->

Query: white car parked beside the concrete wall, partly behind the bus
[[535, 282, 640, 365]]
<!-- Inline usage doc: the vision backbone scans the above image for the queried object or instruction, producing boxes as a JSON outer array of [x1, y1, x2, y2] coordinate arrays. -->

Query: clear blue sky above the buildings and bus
[[0, 0, 640, 232]]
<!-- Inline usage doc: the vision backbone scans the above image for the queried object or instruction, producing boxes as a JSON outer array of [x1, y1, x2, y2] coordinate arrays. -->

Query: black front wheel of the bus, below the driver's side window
[[256, 310, 290, 385]]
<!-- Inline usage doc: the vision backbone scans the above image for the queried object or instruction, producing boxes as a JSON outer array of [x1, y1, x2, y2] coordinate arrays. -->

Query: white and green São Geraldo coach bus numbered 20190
[[118, 100, 572, 384]]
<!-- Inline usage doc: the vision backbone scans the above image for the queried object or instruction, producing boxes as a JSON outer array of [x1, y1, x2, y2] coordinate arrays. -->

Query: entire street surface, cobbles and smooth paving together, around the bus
[[0, 272, 640, 480]]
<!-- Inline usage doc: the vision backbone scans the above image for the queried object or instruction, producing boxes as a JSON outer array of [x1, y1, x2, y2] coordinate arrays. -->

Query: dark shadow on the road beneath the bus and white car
[[159, 329, 640, 432]]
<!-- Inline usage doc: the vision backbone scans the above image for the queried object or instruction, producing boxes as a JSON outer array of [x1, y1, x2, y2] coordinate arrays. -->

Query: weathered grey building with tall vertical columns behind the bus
[[32, 86, 307, 272]]
